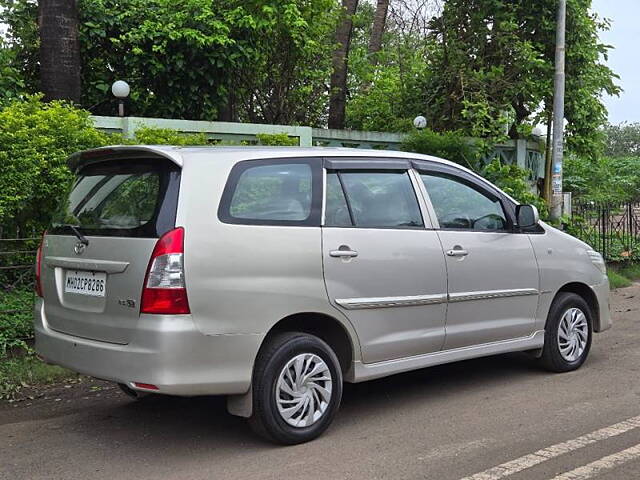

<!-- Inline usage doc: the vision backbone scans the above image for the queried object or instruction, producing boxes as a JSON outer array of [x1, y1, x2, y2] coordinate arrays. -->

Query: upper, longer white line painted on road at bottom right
[[461, 416, 640, 480]]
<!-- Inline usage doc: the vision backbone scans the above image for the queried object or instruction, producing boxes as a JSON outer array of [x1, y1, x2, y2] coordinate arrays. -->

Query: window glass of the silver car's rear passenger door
[[327, 171, 424, 228]]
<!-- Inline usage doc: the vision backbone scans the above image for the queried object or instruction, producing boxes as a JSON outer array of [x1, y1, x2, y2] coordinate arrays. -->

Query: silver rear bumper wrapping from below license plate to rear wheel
[[34, 299, 264, 396]]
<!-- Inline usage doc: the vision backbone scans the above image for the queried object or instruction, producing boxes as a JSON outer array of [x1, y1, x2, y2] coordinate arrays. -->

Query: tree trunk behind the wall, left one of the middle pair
[[329, 0, 358, 129]]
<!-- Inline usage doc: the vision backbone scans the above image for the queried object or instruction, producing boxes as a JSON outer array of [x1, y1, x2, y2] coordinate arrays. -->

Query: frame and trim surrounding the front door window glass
[[412, 161, 519, 233]]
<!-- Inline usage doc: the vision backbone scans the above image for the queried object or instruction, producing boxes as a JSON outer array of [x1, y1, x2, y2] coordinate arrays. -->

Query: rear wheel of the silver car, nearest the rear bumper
[[249, 332, 342, 445]]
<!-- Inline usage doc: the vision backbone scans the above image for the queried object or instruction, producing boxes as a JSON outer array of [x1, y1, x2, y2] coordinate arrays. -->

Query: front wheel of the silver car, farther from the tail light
[[540, 292, 593, 373]]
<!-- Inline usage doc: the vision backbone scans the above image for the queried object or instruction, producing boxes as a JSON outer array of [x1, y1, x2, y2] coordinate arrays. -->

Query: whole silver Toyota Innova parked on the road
[[35, 146, 611, 444]]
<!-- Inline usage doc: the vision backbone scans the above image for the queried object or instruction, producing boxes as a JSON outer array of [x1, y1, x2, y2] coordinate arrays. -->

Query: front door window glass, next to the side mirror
[[420, 173, 507, 230]]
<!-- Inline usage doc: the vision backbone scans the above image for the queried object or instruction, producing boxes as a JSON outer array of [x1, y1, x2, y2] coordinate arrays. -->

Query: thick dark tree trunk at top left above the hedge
[[38, 0, 81, 103]]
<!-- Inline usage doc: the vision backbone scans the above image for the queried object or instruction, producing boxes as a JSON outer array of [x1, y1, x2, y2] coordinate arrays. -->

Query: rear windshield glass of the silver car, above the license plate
[[51, 159, 180, 238]]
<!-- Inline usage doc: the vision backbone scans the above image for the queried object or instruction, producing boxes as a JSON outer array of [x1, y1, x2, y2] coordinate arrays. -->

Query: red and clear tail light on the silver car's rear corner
[[140, 227, 191, 315]]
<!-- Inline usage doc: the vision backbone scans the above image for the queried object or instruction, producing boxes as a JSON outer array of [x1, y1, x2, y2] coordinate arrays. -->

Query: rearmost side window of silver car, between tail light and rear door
[[219, 161, 322, 225]]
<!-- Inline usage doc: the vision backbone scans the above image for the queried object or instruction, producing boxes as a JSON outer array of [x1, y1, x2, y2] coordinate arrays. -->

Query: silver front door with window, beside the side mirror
[[419, 165, 539, 350]]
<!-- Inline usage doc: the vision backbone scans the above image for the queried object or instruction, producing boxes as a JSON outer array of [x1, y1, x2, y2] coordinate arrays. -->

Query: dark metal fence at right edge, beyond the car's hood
[[569, 202, 640, 262]]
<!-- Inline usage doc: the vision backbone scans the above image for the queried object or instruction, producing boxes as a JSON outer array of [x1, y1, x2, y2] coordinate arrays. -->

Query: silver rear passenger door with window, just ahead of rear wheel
[[322, 160, 446, 363]]
